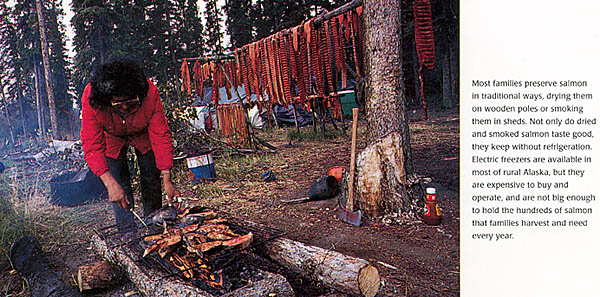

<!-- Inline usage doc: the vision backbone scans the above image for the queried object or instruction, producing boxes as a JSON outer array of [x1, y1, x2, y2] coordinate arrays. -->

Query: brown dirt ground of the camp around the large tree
[[1, 110, 460, 297]]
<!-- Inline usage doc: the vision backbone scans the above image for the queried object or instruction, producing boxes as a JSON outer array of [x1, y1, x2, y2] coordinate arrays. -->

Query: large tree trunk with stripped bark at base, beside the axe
[[353, 0, 423, 217]]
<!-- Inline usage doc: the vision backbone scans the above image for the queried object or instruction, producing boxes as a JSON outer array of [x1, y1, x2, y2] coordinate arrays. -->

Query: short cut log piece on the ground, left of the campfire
[[77, 261, 120, 292]]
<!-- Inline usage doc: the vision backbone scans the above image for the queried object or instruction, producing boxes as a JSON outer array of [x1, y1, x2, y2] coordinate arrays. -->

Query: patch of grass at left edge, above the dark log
[[0, 165, 108, 296]]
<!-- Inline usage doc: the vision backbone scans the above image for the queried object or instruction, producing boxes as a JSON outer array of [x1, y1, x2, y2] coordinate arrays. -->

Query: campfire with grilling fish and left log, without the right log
[[92, 207, 291, 296]]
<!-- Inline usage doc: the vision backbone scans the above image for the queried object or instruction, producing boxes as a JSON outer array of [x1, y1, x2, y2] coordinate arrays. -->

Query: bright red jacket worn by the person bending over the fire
[[81, 81, 173, 176]]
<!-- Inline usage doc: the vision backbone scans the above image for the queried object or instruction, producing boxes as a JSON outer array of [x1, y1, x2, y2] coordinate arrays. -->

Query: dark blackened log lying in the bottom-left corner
[[9, 235, 81, 297]]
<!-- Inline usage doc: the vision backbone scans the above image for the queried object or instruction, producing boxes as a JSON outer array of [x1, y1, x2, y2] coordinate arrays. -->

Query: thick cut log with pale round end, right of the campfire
[[264, 238, 381, 297]]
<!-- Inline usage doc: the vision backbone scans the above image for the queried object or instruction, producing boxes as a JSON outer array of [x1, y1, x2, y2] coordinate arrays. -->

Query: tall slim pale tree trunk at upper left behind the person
[[35, 0, 58, 139]]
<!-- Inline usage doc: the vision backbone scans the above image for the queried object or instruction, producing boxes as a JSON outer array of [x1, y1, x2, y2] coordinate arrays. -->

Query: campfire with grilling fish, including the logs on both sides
[[92, 207, 380, 297]]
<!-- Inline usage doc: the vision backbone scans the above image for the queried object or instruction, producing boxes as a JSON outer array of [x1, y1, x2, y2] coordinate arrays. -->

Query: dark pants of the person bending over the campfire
[[106, 145, 162, 230]]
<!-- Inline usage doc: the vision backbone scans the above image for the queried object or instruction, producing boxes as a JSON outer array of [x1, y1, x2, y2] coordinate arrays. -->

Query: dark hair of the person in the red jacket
[[89, 59, 149, 109]]
